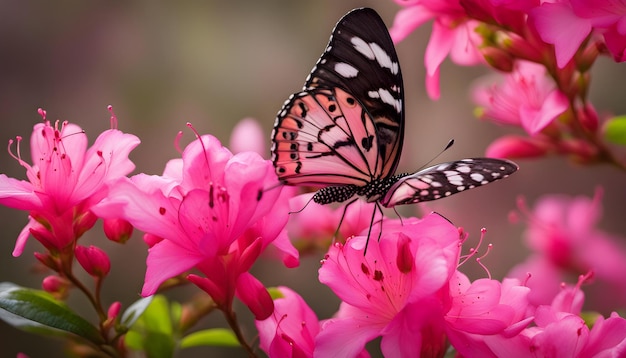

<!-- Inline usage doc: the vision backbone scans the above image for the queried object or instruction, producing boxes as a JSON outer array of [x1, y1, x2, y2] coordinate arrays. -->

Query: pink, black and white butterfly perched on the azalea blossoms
[[272, 8, 518, 234]]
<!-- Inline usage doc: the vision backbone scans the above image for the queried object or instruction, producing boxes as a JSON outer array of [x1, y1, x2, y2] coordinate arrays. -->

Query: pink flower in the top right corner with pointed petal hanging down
[[529, 0, 626, 68]]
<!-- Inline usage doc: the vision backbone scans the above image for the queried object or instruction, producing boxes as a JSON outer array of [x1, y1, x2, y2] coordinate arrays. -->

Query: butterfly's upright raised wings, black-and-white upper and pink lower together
[[272, 9, 404, 186]]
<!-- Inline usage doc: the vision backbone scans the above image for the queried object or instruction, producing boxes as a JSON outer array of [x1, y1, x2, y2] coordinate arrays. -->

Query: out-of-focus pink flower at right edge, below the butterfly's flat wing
[[510, 189, 626, 305]]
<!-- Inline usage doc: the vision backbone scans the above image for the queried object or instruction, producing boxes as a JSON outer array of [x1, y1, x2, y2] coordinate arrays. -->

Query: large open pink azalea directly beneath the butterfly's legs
[[315, 214, 461, 356]]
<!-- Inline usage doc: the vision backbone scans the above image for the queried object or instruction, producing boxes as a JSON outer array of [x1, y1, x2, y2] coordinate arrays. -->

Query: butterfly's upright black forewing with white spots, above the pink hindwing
[[304, 8, 404, 177]]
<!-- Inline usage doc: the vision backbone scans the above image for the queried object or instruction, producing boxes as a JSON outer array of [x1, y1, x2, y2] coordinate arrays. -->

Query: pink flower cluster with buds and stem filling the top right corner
[[390, 0, 626, 168]]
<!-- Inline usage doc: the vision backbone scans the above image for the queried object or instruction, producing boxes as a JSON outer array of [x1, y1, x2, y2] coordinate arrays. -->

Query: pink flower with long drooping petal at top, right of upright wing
[[389, 0, 483, 99]]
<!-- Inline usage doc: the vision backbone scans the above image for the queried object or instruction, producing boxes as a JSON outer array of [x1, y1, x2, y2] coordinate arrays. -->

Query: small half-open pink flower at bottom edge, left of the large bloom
[[256, 286, 320, 357]]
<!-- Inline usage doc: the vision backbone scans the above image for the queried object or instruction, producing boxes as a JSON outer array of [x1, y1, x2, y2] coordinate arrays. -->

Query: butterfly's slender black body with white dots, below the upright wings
[[313, 173, 409, 205]]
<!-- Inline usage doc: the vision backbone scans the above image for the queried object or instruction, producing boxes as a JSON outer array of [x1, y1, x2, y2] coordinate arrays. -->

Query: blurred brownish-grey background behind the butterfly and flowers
[[0, 0, 626, 357]]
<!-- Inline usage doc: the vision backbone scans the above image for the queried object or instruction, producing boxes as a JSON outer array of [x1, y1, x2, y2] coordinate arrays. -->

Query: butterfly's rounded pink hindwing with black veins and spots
[[272, 88, 383, 187]]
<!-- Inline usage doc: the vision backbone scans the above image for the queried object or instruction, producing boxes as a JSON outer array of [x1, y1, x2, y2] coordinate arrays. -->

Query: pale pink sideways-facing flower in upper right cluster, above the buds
[[473, 61, 569, 136]]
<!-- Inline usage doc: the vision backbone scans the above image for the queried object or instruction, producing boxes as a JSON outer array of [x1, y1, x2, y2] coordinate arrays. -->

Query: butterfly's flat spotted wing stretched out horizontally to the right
[[380, 158, 518, 208]]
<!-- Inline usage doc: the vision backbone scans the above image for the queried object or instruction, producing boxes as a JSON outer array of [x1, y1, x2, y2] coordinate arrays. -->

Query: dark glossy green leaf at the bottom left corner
[[0, 282, 103, 344]]
